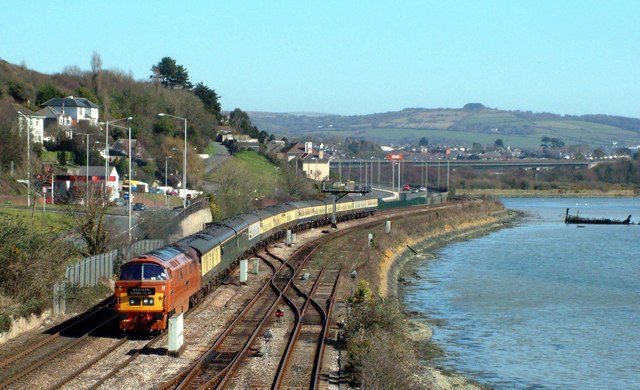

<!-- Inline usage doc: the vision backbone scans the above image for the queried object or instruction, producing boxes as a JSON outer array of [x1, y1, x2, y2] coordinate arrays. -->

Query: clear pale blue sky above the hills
[[0, 0, 640, 118]]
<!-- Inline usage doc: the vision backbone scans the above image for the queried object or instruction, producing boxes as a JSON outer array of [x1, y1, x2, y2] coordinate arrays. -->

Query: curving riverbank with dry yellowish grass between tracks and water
[[379, 203, 521, 389]]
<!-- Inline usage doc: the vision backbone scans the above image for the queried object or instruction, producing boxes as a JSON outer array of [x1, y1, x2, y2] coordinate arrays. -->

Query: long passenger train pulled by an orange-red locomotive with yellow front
[[114, 195, 378, 332]]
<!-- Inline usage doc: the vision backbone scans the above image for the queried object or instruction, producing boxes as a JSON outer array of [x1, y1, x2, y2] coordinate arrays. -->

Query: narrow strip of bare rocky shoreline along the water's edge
[[386, 209, 522, 390]]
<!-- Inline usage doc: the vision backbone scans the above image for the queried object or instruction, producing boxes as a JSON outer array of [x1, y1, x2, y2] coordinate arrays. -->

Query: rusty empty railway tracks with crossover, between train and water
[[153, 201, 458, 389]]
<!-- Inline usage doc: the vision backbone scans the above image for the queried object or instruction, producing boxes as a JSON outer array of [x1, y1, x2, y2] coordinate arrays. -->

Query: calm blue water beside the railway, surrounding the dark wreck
[[405, 199, 640, 389]]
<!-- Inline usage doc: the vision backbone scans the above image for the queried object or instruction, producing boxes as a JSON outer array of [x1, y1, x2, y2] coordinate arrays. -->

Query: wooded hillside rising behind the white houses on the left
[[0, 58, 218, 187]]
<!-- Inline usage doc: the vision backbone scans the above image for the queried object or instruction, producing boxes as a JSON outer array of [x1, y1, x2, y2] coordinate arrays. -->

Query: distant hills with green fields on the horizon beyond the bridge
[[249, 103, 640, 148]]
